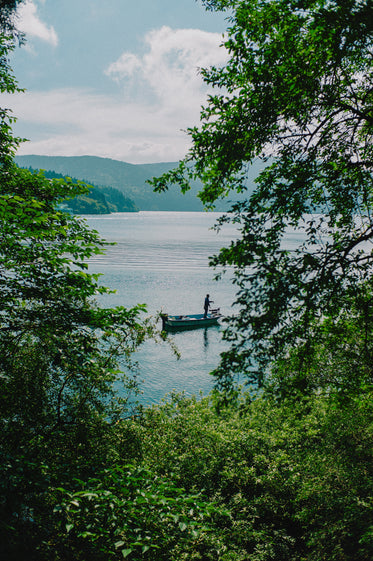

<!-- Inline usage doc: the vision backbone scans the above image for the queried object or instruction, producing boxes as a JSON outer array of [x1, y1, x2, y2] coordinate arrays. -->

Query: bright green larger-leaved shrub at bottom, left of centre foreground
[[50, 465, 222, 560]]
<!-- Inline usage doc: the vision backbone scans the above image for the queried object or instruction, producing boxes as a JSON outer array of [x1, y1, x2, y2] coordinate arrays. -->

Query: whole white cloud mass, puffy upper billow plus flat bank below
[[8, 27, 226, 163]]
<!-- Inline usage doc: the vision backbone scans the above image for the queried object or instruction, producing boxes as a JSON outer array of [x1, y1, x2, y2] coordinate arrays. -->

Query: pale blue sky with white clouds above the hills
[[2, 0, 228, 164]]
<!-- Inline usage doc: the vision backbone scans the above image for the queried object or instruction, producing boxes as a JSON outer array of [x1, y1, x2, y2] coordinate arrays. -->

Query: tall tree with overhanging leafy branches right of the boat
[[153, 0, 373, 394]]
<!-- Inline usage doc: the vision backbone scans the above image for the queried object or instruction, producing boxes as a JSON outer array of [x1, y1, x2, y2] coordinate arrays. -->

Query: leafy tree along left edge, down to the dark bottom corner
[[0, 2, 155, 559]]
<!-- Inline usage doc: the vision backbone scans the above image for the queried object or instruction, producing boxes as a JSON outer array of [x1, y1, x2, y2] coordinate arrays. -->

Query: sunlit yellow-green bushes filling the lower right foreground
[[137, 390, 373, 561]]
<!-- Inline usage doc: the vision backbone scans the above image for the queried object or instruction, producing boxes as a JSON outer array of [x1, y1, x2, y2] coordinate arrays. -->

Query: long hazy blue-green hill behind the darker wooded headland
[[15, 155, 258, 211]]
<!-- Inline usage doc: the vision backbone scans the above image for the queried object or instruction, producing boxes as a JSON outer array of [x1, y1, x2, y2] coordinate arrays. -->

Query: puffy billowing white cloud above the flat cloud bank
[[106, 26, 227, 116]]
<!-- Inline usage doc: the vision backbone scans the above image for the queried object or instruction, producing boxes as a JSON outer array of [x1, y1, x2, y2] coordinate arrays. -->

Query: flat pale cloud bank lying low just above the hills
[[6, 89, 193, 163]]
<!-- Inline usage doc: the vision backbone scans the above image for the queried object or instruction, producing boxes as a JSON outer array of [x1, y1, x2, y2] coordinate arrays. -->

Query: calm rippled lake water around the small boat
[[85, 212, 236, 405]]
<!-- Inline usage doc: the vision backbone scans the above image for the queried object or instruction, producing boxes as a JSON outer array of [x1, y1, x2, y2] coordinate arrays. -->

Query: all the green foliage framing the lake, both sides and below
[[0, 0, 373, 561]]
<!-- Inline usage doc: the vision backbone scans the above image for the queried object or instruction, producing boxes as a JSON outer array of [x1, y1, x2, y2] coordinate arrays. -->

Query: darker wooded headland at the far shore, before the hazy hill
[[21, 167, 139, 214]]
